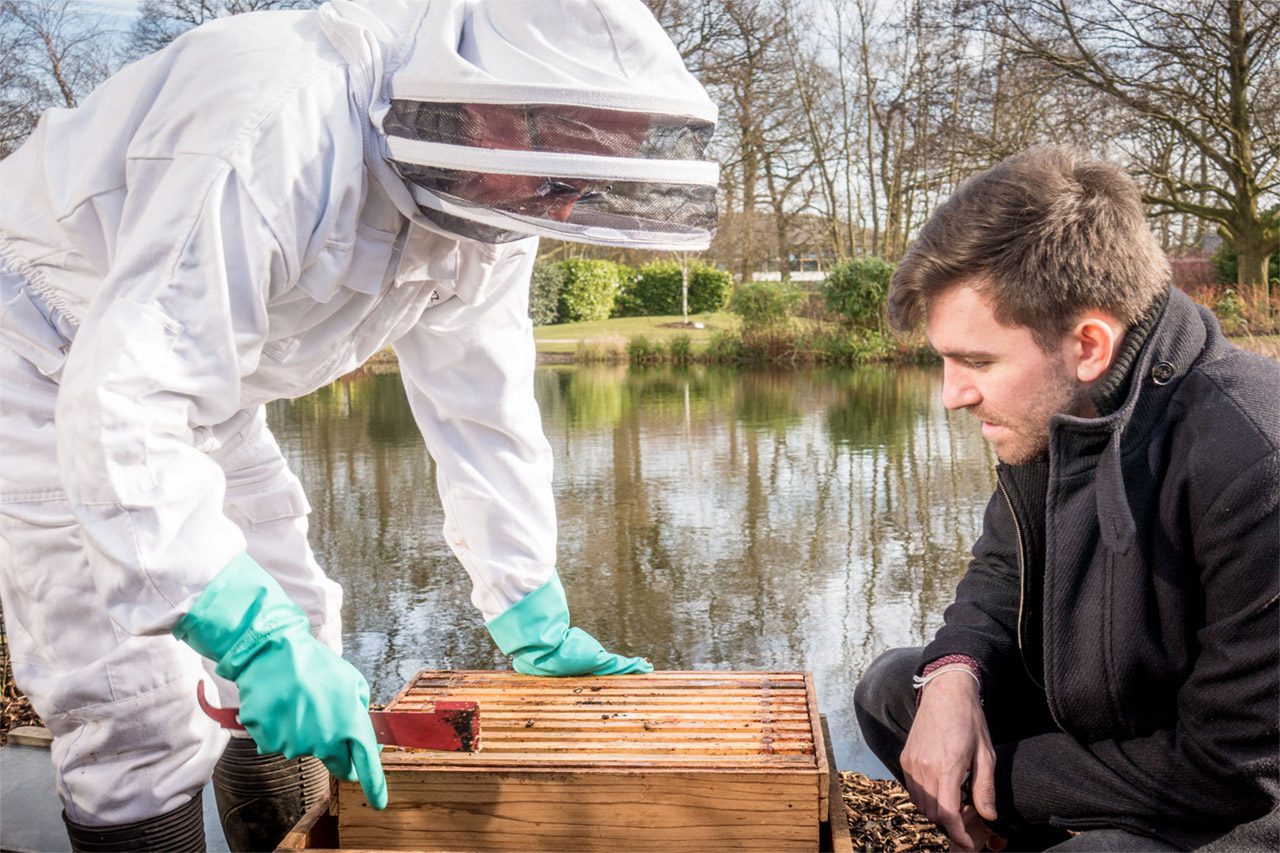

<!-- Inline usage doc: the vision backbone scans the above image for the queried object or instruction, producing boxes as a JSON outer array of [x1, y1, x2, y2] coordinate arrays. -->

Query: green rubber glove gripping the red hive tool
[[173, 553, 387, 808]]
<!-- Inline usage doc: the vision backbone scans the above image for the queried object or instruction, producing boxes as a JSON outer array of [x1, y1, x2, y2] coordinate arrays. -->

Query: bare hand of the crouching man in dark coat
[[901, 671, 1004, 850]]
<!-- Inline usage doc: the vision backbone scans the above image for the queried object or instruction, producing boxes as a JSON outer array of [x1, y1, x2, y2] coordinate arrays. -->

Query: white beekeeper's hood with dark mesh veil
[[380, 0, 719, 250]]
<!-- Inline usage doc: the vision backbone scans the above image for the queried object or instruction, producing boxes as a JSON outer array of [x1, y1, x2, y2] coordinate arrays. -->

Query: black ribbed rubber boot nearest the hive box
[[214, 738, 329, 853]]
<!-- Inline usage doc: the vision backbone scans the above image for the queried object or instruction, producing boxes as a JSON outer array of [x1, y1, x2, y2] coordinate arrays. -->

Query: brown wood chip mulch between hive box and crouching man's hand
[[840, 771, 948, 853]]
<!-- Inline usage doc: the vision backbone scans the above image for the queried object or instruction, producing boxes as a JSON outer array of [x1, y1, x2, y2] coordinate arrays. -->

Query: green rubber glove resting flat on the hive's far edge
[[485, 573, 653, 675]]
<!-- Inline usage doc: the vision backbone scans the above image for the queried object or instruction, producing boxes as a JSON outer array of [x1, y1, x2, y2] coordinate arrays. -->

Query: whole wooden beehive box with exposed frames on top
[[282, 671, 847, 852]]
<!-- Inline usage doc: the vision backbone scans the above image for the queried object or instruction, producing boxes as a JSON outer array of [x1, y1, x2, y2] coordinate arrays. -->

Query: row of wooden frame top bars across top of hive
[[383, 670, 827, 774]]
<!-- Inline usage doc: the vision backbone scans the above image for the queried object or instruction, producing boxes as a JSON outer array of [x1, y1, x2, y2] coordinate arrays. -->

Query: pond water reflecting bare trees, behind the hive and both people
[[268, 366, 995, 776]]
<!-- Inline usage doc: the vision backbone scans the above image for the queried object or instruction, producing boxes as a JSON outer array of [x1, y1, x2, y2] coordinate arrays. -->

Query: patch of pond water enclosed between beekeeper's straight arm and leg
[[268, 374, 502, 701]]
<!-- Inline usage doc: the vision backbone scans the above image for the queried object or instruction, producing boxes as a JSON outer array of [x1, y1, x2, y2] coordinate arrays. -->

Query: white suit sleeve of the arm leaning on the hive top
[[396, 241, 556, 620]]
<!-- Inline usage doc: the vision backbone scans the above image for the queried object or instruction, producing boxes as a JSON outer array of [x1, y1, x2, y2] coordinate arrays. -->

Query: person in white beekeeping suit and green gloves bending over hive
[[0, 0, 718, 850]]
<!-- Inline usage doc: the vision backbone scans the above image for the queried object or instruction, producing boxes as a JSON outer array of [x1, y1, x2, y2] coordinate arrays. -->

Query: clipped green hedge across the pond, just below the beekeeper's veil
[[529, 259, 733, 325]]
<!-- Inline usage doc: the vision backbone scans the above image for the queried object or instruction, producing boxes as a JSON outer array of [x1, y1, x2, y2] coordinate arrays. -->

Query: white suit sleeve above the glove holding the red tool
[[56, 155, 288, 634]]
